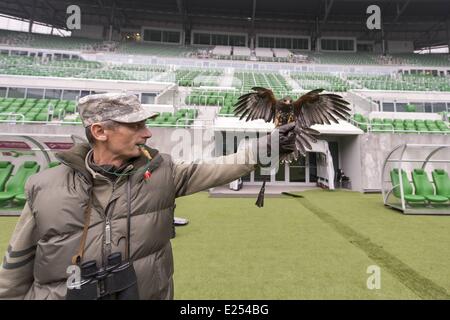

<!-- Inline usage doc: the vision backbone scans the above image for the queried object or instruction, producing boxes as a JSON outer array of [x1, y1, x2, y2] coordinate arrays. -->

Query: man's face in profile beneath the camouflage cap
[[105, 120, 152, 159]]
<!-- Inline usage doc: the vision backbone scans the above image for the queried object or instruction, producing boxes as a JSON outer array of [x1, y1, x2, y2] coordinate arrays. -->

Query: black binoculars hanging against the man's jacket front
[[66, 252, 139, 300]]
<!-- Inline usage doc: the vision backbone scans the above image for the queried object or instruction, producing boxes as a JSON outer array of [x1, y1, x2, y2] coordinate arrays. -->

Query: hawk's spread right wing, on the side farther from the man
[[292, 89, 350, 128]]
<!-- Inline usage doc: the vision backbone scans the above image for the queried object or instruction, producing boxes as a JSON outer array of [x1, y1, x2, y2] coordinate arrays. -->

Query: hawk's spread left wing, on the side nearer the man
[[234, 87, 277, 122]]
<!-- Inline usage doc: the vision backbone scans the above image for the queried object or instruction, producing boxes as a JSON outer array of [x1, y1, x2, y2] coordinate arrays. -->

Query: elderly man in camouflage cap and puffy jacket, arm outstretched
[[0, 94, 294, 299]]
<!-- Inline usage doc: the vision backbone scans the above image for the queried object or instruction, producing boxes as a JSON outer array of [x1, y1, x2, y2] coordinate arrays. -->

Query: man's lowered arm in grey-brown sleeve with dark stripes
[[0, 203, 36, 299]]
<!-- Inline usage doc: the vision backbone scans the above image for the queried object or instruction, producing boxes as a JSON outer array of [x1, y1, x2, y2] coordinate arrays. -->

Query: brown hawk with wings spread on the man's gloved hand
[[234, 87, 350, 160]]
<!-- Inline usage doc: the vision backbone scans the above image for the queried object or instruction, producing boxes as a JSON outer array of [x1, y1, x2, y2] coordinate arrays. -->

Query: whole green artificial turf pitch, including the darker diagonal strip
[[0, 190, 450, 299]]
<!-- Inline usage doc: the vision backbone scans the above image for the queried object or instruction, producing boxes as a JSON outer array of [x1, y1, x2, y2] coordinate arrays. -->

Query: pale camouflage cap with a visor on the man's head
[[78, 93, 158, 127]]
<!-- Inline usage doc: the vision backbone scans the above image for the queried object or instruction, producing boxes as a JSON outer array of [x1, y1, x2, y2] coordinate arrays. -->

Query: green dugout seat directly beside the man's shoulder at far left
[[0, 161, 40, 204]]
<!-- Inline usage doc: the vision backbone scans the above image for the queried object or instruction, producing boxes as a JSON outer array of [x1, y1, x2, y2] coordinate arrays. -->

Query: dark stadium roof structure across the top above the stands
[[0, 0, 450, 48]]
